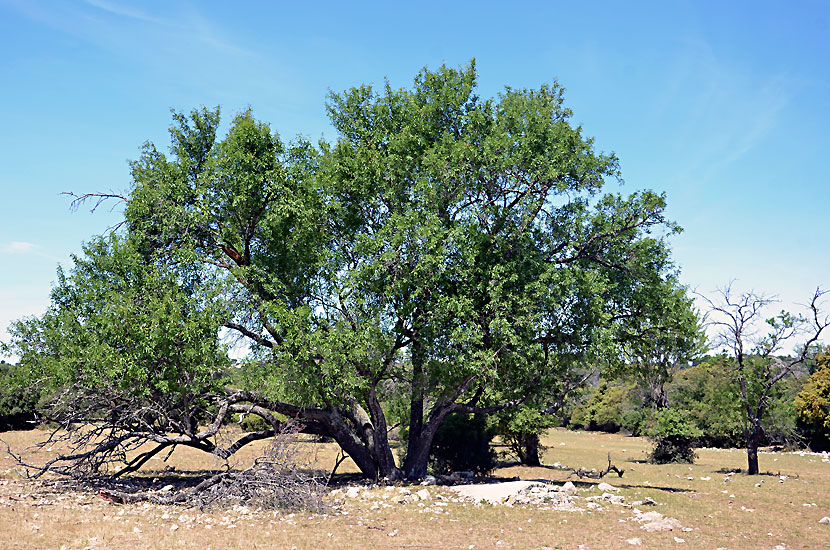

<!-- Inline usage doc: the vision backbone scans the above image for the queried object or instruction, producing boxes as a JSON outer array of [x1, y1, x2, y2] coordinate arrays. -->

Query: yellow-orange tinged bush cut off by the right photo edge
[[794, 353, 830, 450]]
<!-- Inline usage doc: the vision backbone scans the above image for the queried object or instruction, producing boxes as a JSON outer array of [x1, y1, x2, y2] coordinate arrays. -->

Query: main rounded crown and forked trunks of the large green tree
[[8, 64, 688, 484]]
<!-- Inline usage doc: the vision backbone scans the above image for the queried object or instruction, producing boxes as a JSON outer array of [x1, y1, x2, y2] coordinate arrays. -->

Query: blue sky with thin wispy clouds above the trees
[[0, 0, 830, 358]]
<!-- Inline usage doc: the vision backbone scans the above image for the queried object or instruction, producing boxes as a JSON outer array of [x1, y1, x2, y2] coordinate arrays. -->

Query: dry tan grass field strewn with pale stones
[[0, 430, 830, 550]]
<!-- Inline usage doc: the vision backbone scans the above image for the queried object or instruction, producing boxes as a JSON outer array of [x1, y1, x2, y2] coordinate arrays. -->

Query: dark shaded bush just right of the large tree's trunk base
[[430, 413, 496, 475]]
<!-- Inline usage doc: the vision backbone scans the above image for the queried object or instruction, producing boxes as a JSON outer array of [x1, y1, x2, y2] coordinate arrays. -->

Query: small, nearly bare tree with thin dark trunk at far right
[[701, 285, 830, 475]]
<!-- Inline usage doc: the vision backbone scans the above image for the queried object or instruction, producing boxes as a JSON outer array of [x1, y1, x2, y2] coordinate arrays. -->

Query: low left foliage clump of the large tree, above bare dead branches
[[5, 235, 228, 440]]
